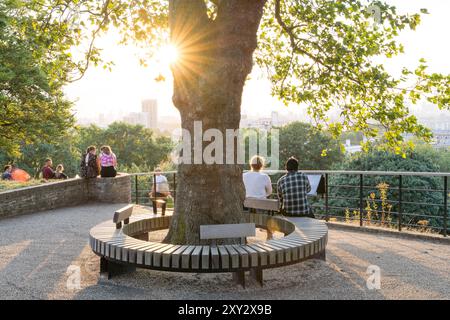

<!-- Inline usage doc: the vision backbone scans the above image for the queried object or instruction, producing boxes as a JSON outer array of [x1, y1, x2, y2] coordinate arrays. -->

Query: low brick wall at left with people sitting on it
[[0, 174, 131, 218]]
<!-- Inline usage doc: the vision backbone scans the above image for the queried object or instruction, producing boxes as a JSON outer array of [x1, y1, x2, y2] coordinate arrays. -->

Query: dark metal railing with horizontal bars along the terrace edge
[[131, 170, 450, 237]]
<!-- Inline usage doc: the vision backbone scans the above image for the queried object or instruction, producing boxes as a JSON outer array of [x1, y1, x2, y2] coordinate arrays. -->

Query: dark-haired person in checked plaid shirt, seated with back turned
[[277, 157, 314, 217]]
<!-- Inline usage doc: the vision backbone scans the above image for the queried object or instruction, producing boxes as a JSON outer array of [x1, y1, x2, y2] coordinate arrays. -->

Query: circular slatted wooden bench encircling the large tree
[[89, 205, 328, 284]]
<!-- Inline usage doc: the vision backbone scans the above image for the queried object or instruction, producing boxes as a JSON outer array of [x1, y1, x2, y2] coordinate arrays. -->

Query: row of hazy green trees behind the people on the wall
[[0, 123, 172, 177]]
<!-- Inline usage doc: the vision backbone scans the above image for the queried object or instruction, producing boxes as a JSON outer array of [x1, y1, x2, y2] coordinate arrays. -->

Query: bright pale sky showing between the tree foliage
[[65, 0, 450, 118]]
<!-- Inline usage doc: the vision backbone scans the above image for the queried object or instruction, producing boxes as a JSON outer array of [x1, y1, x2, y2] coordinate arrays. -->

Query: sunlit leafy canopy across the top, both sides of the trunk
[[0, 0, 450, 153]]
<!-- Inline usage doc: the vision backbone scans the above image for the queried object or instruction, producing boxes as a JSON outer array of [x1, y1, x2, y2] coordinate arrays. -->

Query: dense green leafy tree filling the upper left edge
[[0, 0, 74, 156]]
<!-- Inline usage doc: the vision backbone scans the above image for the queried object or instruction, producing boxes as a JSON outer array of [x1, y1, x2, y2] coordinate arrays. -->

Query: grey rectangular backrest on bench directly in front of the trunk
[[200, 223, 256, 244]]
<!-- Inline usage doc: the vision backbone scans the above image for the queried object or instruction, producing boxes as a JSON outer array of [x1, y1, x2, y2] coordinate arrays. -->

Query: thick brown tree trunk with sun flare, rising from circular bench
[[166, 0, 266, 244]]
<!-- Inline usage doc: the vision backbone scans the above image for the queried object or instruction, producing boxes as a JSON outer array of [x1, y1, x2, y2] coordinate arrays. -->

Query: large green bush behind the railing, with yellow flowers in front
[[329, 148, 444, 227]]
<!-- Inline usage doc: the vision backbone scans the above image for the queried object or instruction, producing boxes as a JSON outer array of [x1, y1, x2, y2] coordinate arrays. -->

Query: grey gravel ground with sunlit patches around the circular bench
[[0, 204, 450, 299]]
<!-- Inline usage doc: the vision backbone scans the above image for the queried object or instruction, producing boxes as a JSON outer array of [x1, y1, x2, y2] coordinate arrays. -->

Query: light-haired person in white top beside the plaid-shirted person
[[243, 156, 272, 199]]
